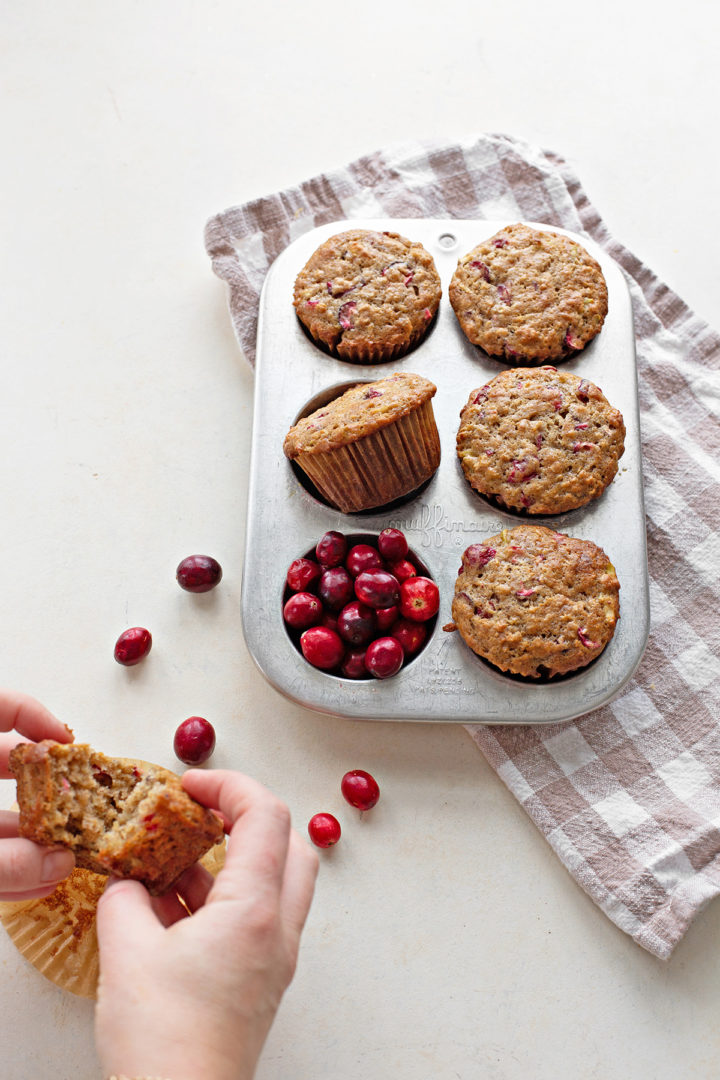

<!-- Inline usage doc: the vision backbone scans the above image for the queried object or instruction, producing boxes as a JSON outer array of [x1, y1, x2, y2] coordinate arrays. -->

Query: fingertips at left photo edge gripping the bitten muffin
[[0, 690, 74, 900]]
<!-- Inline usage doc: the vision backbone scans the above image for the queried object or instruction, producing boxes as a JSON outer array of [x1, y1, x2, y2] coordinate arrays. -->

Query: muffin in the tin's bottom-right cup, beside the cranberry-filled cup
[[452, 525, 620, 678]]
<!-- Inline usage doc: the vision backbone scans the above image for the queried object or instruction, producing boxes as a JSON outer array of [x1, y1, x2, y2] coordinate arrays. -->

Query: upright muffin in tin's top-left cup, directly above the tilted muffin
[[293, 229, 441, 364]]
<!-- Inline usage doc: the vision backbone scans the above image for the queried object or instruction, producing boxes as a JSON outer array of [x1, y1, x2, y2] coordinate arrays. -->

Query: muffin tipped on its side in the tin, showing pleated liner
[[283, 373, 440, 514]]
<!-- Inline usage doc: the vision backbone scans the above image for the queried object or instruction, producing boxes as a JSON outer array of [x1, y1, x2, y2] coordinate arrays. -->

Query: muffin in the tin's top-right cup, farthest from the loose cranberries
[[449, 225, 608, 363]]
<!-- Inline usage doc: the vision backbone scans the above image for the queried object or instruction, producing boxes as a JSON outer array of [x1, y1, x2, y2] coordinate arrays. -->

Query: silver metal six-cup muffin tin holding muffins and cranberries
[[242, 218, 649, 724]]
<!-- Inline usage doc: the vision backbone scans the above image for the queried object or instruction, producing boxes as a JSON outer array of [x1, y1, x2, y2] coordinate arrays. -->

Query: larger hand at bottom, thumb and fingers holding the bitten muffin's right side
[[95, 770, 317, 1080]]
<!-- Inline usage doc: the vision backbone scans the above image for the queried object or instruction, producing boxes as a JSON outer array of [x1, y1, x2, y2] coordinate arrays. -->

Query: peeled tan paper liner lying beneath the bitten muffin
[[0, 829, 226, 998]]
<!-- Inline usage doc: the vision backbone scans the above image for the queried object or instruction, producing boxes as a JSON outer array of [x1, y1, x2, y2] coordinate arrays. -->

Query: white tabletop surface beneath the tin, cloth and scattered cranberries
[[0, 0, 720, 1080]]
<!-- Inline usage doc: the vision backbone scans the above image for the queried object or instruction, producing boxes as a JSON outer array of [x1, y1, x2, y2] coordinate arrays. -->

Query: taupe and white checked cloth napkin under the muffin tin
[[205, 135, 720, 958]]
